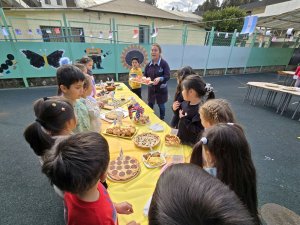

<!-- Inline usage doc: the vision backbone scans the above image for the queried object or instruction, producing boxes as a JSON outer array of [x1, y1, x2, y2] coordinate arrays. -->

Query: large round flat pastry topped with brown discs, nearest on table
[[107, 155, 141, 182]]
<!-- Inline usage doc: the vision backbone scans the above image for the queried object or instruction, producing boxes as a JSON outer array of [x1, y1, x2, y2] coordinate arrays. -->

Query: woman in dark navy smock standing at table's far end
[[144, 43, 170, 120]]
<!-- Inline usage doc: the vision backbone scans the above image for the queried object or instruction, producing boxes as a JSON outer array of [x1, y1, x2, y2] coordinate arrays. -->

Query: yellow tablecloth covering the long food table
[[98, 83, 192, 225]]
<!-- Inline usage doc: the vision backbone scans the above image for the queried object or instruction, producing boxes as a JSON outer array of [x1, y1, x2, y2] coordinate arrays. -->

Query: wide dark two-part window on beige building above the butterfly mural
[[40, 26, 85, 42]]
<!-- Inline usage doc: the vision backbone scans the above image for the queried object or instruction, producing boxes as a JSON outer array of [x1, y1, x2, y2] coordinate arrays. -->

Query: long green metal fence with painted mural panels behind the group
[[0, 9, 299, 86]]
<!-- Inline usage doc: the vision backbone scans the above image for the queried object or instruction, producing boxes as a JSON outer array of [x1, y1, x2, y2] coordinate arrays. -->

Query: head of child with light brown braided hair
[[199, 99, 236, 128]]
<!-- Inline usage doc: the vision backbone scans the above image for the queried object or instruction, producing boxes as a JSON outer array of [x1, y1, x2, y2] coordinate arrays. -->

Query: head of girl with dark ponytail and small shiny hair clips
[[24, 97, 76, 163]]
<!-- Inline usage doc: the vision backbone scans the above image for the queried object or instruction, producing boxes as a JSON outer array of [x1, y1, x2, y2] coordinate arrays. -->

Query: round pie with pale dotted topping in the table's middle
[[133, 132, 160, 149]]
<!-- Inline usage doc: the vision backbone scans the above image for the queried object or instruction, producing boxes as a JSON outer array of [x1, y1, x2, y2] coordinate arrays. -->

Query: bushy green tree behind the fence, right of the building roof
[[203, 7, 246, 32]]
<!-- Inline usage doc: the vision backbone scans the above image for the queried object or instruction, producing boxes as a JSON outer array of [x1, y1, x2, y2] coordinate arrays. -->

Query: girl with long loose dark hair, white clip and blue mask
[[190, 123, 260, 224]]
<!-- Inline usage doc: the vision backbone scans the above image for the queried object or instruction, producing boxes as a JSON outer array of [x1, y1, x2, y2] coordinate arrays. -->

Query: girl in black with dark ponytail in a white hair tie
[[177, 75, 215, 145]]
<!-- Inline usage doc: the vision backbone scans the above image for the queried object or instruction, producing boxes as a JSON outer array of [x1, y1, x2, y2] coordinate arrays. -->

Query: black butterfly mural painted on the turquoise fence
[[20, 49, 65, 69]]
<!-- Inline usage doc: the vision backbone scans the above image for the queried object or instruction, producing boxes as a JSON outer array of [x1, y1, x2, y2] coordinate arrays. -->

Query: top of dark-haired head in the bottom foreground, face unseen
[[148, 164, 255, 225]]
